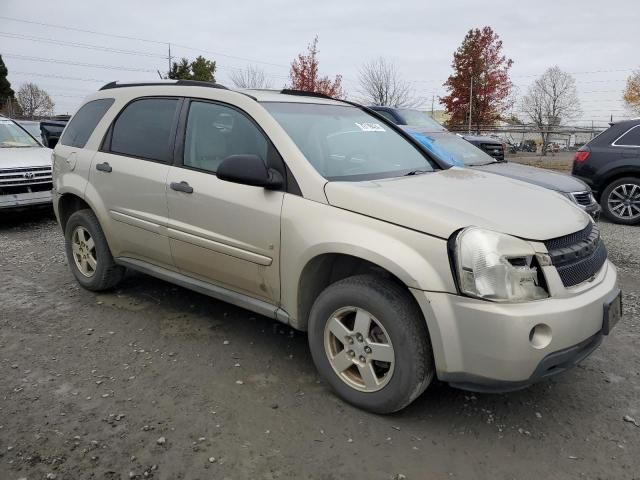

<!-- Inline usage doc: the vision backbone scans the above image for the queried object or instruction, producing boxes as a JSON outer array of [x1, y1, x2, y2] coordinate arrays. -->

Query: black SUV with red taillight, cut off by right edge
[[572, 118, 640, 225]]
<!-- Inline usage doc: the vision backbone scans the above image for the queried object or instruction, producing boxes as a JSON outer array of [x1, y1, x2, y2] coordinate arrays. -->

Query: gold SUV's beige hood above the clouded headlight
[[325, 167, 590, 241]]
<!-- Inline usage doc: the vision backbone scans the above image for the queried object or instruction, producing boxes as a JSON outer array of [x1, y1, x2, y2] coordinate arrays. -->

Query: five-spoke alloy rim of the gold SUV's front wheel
[[324, 307, 395, 392]]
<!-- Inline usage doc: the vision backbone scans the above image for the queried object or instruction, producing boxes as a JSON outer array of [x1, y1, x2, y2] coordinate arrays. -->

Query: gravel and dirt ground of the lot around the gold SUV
[[0, 211, 640, 480]]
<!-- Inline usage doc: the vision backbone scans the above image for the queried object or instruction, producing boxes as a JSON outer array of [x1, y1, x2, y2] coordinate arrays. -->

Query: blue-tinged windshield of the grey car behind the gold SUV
[[406, 128, 496, 167]]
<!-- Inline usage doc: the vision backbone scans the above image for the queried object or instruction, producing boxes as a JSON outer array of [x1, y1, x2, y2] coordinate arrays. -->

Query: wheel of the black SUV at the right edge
[[600, 177, 640, 225]]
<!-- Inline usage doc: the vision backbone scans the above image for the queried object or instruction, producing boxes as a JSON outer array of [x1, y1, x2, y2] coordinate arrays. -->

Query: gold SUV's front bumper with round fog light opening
[[412, 261, 618, 392]]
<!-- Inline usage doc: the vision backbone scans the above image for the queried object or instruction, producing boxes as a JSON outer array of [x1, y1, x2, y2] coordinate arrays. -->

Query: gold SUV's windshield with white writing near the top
[[263, 102, 433, 181]]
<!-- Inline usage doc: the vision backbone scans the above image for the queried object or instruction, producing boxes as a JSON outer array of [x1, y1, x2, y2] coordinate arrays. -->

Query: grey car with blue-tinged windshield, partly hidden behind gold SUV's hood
[[402, 124, 600, 220]]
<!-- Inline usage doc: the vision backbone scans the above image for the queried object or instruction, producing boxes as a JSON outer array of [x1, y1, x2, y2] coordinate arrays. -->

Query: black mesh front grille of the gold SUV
[[544, 223, 607, 287]]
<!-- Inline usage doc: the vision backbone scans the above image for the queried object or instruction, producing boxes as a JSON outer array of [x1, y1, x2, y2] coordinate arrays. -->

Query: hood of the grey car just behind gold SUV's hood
[[473, 162, 591, 193]]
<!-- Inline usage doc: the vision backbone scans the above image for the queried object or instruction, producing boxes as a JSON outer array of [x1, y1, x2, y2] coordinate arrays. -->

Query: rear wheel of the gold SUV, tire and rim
[[64, 210, 125, 291]]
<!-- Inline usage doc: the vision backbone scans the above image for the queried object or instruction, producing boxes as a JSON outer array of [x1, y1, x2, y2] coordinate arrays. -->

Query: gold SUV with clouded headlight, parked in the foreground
[[53, 81, 621, 413]]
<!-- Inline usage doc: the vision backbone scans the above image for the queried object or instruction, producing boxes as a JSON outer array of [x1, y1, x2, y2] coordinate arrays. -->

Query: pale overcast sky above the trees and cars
[[0, 0, 640, 126]]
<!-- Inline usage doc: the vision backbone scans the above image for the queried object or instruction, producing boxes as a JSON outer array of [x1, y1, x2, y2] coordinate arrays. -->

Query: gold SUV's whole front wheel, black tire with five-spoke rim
[[308, 275, 435, 413]]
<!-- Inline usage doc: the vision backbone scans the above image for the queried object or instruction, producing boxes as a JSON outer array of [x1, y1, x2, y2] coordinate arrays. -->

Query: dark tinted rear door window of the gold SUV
[[108, 98, 179, 162]]
